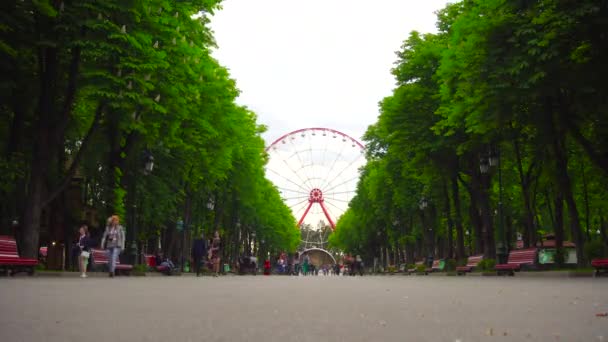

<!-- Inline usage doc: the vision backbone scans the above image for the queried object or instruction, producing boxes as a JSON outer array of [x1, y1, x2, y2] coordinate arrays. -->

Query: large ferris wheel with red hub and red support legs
[[266, 128, 365, 229]]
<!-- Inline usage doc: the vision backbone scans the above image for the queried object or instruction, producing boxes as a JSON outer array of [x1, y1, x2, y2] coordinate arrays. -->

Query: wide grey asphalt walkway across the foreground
[[0, 276, 608, 342]]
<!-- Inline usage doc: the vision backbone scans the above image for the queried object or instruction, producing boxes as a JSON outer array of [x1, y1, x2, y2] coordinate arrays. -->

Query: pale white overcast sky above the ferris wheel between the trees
[[211, 0, 453, 142]]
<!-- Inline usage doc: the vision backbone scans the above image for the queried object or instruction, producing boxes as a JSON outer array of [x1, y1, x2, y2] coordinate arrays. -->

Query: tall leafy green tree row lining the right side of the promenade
[[331, 0, 608, 265]]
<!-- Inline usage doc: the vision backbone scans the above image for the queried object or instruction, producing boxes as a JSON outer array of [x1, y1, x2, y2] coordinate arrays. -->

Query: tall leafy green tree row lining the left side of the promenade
[[0, 0, 299, 264]]
